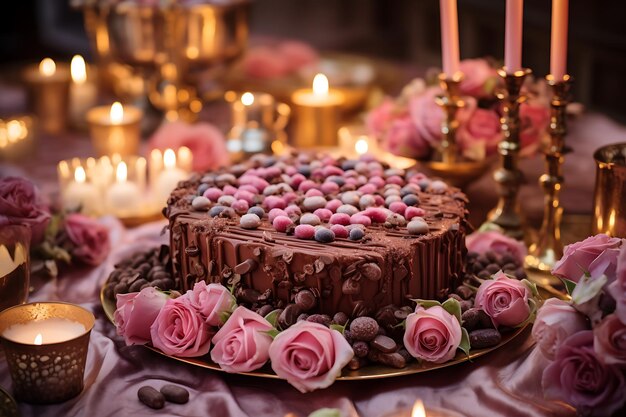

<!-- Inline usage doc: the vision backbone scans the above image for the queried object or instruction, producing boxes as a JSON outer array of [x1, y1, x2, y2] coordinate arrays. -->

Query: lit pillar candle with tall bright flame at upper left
[[70, 55, 98, 126]]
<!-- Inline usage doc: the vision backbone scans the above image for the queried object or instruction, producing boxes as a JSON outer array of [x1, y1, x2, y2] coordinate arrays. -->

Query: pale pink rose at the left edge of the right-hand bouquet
[[532, 298, 589, 359]]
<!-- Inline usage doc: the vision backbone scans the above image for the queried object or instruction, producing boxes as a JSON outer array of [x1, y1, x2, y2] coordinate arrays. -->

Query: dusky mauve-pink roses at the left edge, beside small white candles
[[0, 177, 110, 276]]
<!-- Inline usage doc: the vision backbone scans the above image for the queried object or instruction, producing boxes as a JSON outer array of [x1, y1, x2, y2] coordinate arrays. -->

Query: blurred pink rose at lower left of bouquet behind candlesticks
[[385, 116, 431, 159]]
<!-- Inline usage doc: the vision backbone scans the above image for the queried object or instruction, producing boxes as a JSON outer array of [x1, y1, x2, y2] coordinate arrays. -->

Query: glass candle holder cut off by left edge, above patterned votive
[[0, 225, 30, 311]]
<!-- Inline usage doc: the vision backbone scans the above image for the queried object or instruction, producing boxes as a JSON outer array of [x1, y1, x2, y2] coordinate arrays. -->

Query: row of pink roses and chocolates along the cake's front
[[114, 252, 537, 392]]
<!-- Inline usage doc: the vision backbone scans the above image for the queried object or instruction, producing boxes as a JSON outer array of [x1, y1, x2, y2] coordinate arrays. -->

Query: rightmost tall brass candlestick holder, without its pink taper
[[526, 75, 572, 272]]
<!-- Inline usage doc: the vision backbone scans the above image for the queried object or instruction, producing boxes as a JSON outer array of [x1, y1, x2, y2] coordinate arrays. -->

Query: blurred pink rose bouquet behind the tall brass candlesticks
[[366, 59, 549, 161]]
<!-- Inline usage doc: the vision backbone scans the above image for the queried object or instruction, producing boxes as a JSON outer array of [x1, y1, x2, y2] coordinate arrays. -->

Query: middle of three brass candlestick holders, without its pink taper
[[487, 68, 532, 240]]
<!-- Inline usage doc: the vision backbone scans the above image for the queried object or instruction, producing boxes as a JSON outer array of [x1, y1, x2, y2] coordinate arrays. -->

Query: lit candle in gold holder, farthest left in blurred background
[[24, 58, 70, 134]]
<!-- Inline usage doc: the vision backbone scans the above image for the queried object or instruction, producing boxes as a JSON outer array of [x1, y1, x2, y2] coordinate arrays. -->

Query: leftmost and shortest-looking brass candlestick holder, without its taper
[[435, 72, 465, 164]]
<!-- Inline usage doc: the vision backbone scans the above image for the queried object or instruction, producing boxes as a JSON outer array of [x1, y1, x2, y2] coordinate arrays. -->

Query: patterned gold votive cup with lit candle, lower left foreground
[[0, 302, 95, 404]]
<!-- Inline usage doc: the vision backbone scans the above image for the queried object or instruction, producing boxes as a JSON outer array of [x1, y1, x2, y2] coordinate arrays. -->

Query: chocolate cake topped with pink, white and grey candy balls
[[165, 154, 467, 318]]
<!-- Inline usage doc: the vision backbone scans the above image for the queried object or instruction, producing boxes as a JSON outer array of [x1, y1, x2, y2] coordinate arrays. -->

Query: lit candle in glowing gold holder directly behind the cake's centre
[[291, 74, 345, 148]]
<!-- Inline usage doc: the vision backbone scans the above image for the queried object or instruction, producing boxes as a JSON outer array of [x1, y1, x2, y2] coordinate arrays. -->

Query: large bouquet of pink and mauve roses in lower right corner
[[532, 234, 626, 416]]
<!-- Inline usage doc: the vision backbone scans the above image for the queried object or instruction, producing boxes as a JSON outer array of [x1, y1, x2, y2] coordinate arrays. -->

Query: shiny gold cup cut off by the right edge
[[592, 143, 626, 238]]
